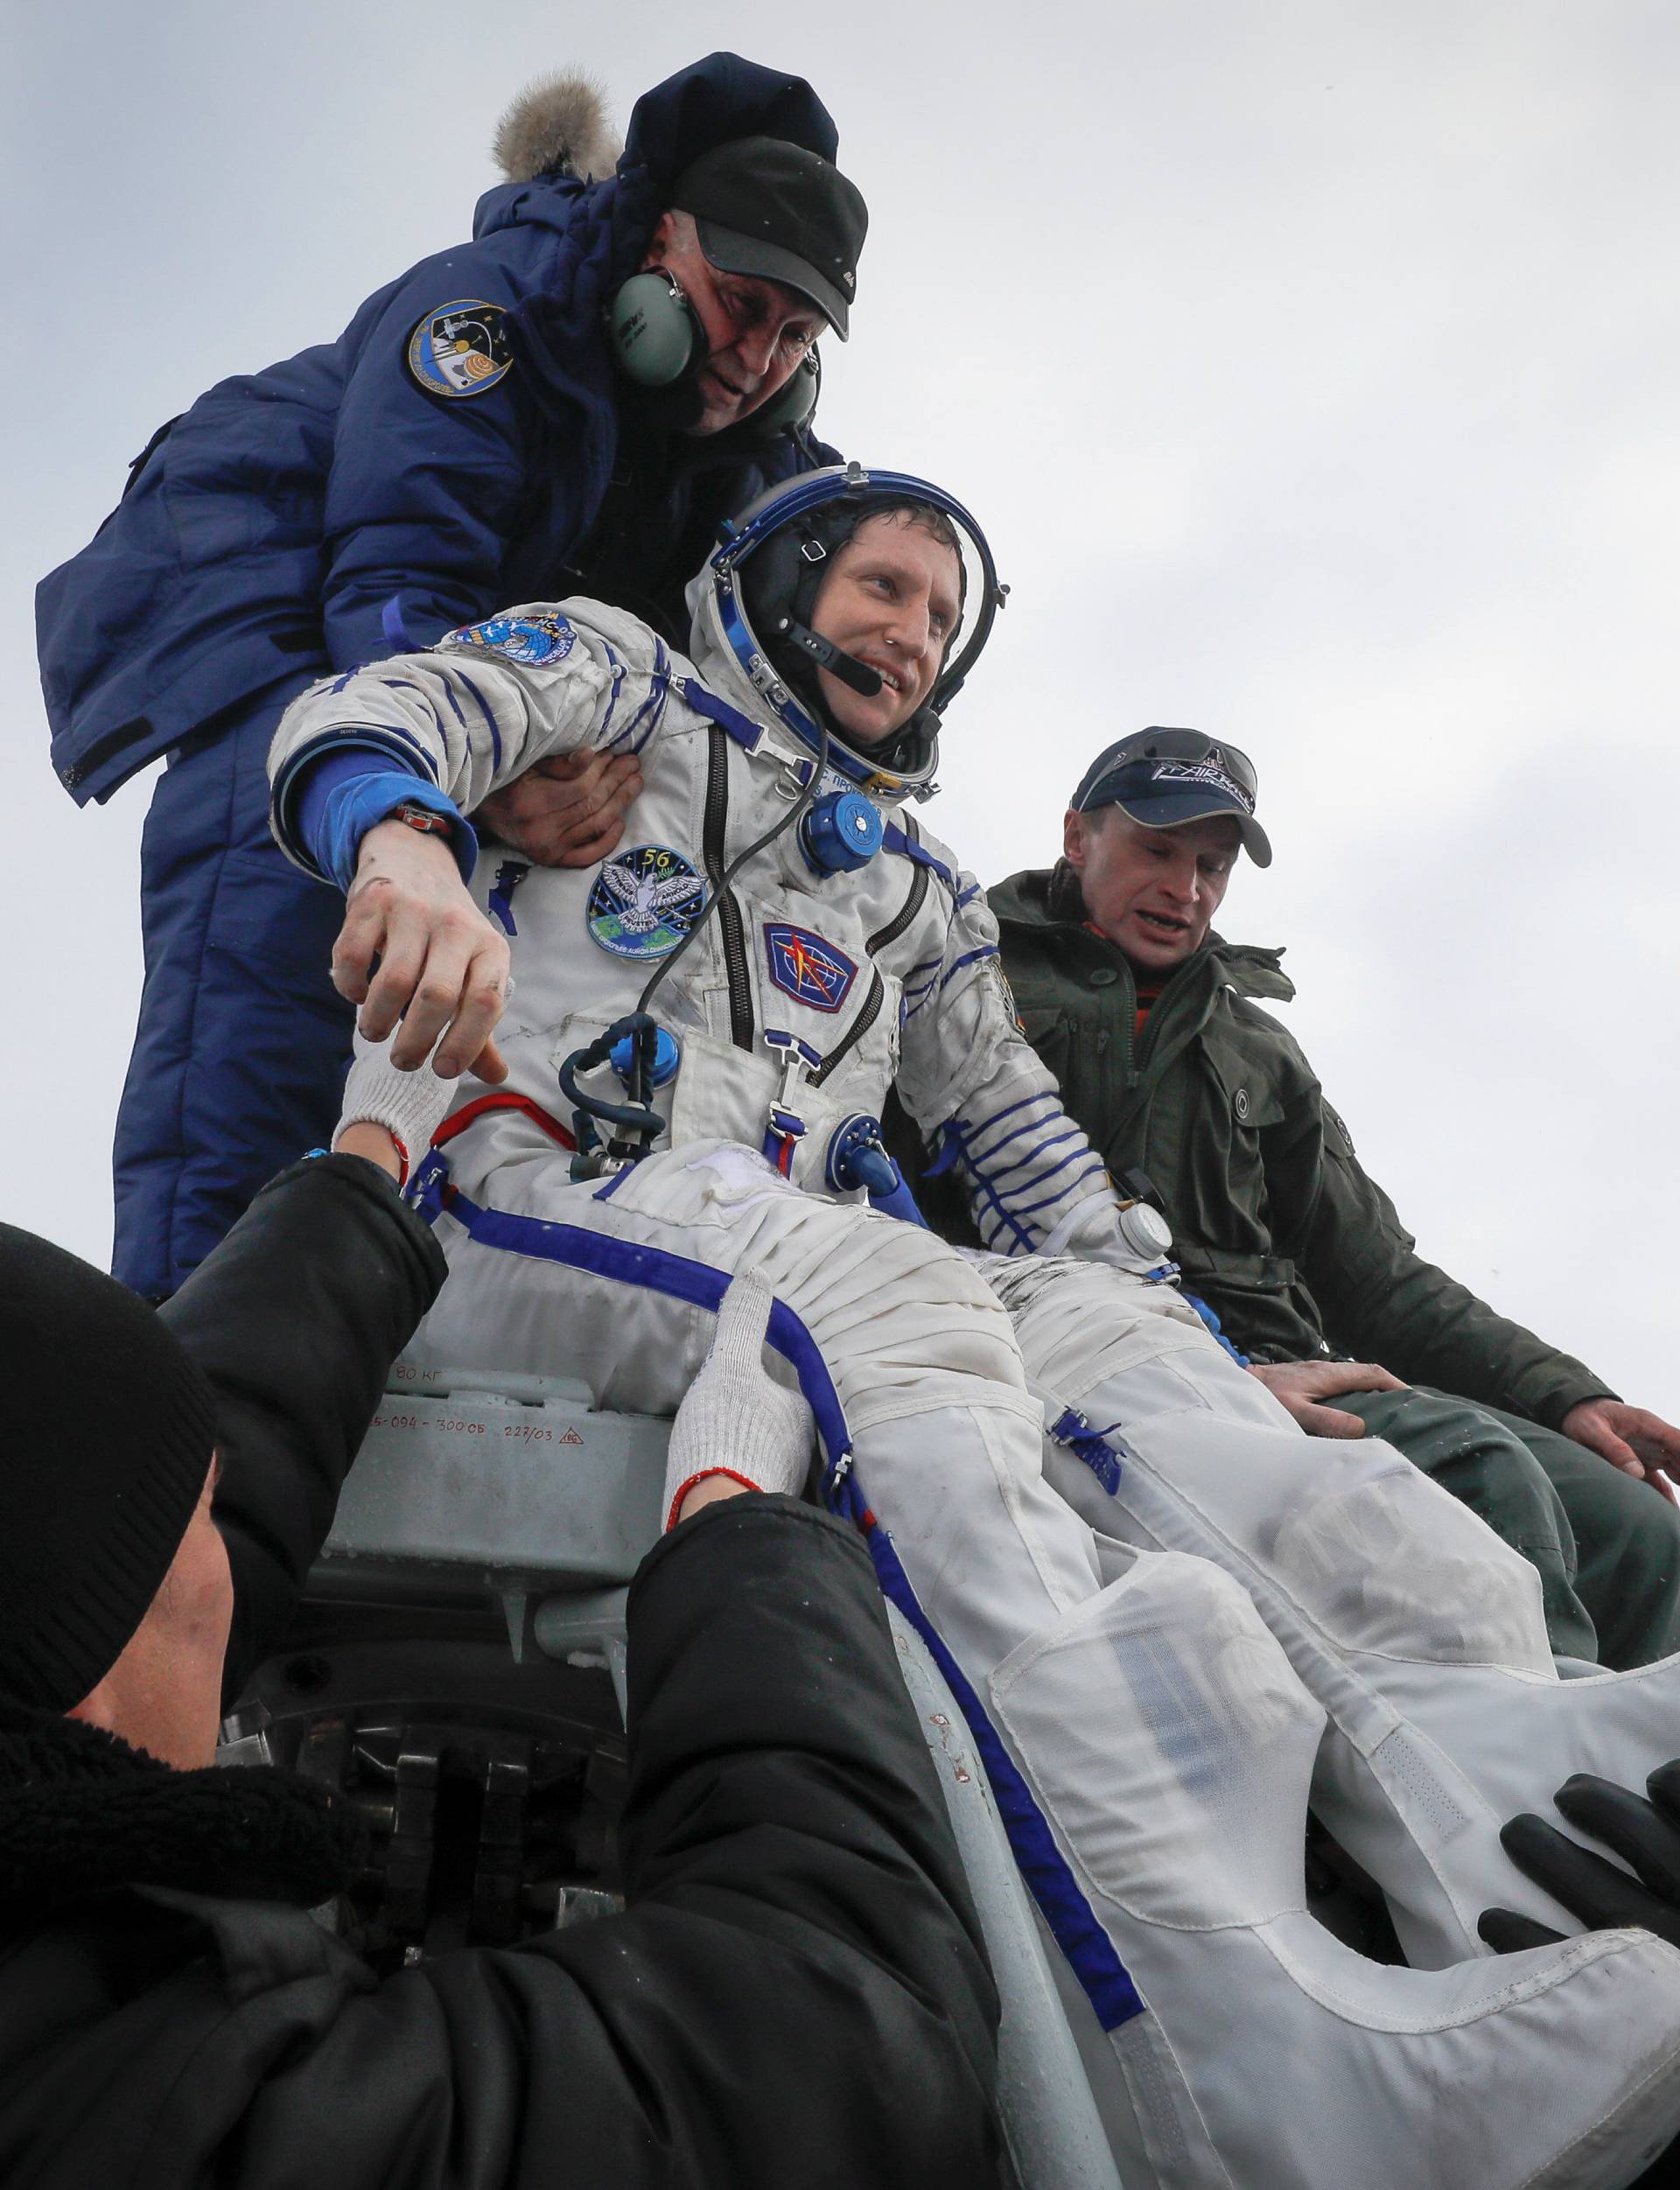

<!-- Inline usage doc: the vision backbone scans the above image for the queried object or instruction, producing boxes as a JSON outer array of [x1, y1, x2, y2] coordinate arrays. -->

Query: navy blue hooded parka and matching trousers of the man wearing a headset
[[26, 52, 836, 1297]]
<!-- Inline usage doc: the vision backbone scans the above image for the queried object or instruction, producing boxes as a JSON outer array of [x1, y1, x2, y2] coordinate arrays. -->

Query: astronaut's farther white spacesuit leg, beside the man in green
[[988, 1262, 1680, 1967]]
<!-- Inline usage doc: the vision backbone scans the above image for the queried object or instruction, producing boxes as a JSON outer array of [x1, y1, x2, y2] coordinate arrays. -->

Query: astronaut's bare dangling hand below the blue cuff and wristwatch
[[332, 822, 508, 1081]]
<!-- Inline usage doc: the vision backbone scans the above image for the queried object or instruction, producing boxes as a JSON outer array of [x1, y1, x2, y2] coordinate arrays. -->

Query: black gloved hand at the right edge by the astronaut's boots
[[1476, 1759, 1680, 1954]]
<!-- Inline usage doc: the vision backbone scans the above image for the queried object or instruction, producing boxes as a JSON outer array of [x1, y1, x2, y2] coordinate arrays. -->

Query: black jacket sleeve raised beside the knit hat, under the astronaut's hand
[[160, 1157, 444, 1699]]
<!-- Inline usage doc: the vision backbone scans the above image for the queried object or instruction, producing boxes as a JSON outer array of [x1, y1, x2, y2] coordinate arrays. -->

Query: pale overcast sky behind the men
[[0, 0, 1680, 1415]]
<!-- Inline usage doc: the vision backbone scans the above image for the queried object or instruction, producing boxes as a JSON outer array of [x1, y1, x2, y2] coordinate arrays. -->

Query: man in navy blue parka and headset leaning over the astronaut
[[38, 52, 867, 1298]]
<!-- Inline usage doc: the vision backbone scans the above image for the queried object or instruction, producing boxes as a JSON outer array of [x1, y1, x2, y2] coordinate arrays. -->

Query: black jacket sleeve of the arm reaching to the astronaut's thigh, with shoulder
[[214, 1498, 997, 2190]]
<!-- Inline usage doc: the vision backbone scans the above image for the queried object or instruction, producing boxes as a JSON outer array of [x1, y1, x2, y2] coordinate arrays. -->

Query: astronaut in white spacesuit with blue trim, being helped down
[[271, 466, 1680, 2190]]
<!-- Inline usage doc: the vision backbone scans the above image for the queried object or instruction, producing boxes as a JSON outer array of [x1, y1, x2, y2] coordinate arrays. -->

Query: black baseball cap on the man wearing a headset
[[670, 138, 870, 341]]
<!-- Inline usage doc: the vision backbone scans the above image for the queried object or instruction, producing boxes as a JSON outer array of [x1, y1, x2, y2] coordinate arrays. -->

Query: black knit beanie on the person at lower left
[[0, 1224, 214, 1711]]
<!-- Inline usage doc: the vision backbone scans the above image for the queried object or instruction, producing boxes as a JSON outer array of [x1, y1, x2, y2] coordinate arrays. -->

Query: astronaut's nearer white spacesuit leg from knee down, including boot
[[990, 1553, 1680, 2190]]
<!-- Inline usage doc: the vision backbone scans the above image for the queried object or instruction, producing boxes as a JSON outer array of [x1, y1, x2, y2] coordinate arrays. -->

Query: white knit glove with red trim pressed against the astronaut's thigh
[[663, 1277, 813, 1529]]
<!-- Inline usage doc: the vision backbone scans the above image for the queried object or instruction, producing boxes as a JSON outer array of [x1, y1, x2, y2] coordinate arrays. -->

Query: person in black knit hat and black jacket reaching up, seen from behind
[[0, 1073, 997, 2190]]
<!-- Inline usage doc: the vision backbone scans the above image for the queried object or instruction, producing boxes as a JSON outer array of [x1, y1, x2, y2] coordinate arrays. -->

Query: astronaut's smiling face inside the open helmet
[[810, 510, 962, 747]]
